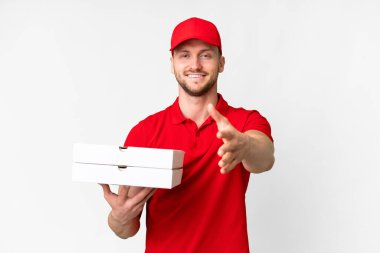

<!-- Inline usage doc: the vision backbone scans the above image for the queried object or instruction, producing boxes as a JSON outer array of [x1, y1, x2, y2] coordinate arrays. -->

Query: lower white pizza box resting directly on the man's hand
[[72, 163, 183, 189]]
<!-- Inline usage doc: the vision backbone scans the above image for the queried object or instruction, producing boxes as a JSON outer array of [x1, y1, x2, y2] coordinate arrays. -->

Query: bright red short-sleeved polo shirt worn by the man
[[124, 94, 272, 253]]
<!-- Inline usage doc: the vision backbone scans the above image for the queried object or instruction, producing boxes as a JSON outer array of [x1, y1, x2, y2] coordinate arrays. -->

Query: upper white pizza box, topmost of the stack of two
[[73, 143, 185, 169]]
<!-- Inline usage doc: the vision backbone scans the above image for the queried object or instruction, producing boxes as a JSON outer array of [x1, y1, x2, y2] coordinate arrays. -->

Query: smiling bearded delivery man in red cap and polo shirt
[[102, 18, 274, 253]]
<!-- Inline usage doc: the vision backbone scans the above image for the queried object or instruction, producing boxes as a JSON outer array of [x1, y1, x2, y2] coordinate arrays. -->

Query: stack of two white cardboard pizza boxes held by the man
[[72, 144, 184, 189]]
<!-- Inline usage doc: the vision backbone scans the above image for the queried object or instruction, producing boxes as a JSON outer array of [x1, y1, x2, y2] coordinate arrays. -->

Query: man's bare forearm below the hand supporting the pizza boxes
[[108, 212, 140, 239]]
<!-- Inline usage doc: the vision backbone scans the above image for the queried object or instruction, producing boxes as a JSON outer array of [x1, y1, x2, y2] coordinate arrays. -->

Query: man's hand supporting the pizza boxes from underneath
[[100, 184, 156, 225]]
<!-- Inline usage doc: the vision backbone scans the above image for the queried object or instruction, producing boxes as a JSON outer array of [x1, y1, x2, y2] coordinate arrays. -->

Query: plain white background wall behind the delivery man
[[0, 0, 380, 253]]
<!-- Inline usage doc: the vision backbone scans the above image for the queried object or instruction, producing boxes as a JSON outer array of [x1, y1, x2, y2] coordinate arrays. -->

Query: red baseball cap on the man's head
[[170, 18, 222, 54]]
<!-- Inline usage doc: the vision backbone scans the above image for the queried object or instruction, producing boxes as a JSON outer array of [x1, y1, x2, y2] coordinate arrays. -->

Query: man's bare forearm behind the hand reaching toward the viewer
[[242, 130, 275, 173]]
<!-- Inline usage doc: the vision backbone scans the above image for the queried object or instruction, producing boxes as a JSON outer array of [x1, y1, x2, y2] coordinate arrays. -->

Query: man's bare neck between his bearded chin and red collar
[[178, 87, 218, 127]]
